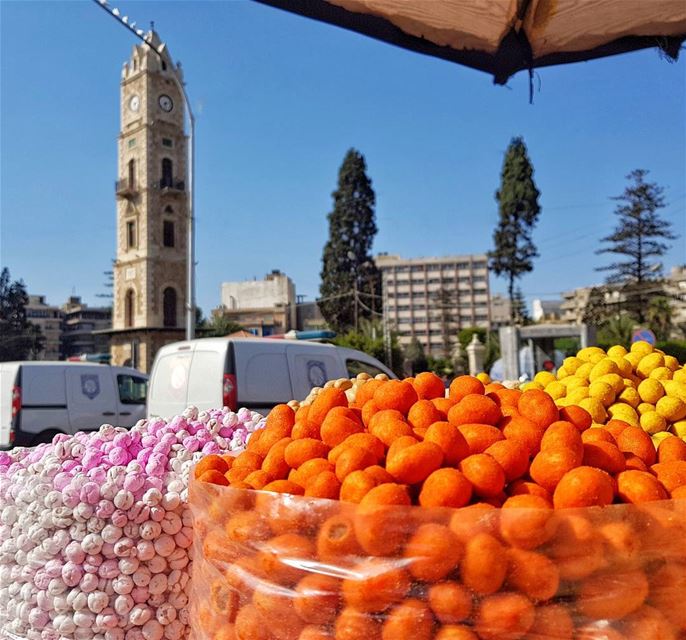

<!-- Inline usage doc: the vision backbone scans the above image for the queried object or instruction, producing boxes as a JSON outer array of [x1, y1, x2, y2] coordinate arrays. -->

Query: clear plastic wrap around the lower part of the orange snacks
[[189, 481, 686, 640]]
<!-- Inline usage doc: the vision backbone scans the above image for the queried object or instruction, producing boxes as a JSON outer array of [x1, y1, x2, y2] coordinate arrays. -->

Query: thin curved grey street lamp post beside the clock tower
[[93, 0, 195, 340]]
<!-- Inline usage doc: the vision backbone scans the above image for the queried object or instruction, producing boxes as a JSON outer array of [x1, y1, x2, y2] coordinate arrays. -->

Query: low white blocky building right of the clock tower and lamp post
[[219, 270, 297, 336]]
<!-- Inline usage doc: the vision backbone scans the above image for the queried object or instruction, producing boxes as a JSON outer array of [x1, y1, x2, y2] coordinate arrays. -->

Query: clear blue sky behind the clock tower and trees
[[0, 0, 686, 314]]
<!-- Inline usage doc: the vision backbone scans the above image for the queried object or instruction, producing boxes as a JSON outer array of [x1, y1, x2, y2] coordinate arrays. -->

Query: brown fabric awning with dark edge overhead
[[256, 0, 686, 84]]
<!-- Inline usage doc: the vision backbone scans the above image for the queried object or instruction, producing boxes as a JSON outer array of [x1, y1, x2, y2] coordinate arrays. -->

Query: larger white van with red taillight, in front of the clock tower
[[148, 338, 396, 418]]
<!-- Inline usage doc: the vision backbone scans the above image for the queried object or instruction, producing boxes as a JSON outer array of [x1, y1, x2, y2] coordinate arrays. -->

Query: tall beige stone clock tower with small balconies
[[110, 31, 188, 371]]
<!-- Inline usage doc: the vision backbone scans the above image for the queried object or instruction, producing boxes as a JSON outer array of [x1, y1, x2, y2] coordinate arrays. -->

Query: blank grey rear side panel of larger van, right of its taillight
[[245, 353, 292, 404]]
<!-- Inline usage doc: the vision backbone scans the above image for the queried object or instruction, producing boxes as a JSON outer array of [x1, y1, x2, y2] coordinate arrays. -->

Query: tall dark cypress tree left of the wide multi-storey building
[[319, 149, 381, 332]]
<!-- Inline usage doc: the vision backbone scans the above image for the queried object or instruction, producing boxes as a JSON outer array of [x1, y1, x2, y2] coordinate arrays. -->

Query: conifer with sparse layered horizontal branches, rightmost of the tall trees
[[596, 169, 677, 323]]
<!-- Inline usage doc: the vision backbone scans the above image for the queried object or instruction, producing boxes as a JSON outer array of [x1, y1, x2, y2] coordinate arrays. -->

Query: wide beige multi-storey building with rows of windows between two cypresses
[[375, 254, 491, 357]]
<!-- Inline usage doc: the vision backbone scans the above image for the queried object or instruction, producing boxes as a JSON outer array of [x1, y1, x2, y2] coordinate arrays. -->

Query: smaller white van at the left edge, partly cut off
[[0, 360, 148, 449]]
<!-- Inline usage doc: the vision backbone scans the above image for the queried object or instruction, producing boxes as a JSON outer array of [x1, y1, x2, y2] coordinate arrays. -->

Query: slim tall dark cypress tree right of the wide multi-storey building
[[488, 138, 541, 323]]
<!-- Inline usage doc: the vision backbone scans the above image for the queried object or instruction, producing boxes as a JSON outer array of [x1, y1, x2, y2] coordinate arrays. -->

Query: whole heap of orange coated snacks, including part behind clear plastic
[[190, 373, 686, 640]]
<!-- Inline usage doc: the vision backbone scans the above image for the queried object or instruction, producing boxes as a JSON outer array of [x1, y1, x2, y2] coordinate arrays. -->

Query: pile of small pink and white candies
[[0, 407, 263, 640]]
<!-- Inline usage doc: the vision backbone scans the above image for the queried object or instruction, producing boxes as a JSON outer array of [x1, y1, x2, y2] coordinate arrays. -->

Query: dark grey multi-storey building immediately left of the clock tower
[[61, 296, 112, 359]]
